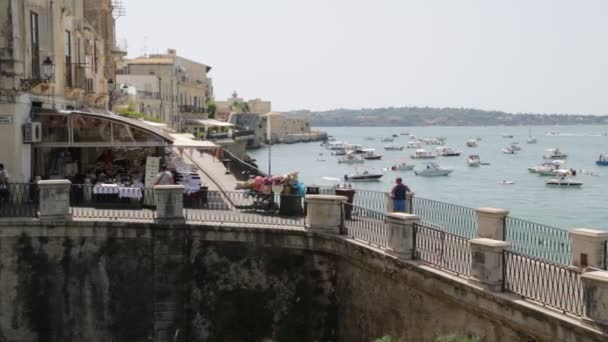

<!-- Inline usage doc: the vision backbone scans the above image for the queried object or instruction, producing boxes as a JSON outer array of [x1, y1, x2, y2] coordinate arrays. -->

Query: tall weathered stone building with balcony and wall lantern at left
[[0, 0, 122, 182]]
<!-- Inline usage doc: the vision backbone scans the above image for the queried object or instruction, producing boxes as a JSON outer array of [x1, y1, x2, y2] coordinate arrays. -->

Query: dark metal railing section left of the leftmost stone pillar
[[0, 183, 39, 218]]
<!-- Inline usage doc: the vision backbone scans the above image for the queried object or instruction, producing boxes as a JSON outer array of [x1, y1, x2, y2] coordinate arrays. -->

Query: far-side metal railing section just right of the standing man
[[412, 197, 477, 239]]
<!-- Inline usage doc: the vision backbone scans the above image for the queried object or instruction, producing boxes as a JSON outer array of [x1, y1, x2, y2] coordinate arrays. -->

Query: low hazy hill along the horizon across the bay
[[285, 107, 608, 127]]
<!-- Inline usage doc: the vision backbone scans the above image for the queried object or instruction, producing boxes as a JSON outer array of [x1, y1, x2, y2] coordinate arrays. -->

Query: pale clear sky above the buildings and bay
[[117, 0, 608, 115]]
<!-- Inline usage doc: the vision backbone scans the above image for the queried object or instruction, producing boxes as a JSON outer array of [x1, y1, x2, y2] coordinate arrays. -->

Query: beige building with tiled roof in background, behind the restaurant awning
[[118, 49, 213, 130]]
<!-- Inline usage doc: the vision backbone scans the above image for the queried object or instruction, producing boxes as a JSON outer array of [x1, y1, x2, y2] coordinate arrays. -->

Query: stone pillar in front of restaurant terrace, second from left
[[154, 185, 186, 224]]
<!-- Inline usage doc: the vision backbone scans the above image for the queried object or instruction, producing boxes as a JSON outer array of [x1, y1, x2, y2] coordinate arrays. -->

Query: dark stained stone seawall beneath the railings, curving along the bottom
[[0, 220, 607, 342]]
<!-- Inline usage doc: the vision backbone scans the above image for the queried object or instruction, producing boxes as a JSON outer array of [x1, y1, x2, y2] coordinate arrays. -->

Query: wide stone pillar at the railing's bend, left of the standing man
[[306, 195, 347, 235]]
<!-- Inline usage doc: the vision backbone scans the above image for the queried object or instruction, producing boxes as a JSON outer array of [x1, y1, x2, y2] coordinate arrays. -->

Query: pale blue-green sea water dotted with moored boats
[[249, 125, 608, 230]]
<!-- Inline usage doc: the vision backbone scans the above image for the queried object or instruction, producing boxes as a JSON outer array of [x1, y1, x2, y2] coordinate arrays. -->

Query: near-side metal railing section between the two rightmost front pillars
[[503, 251, 584, 316]]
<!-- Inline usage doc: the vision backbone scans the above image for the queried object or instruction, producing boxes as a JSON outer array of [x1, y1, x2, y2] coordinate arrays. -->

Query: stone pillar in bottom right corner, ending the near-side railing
[[581, 271, 608, 325]]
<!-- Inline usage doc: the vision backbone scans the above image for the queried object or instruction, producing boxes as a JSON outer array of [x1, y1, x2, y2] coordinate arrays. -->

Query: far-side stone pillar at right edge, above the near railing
[[570, 228, 608, 269]]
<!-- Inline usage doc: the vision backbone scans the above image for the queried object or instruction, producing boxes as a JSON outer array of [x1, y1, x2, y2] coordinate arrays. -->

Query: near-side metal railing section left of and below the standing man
[[342, 203, 390, 248]]
